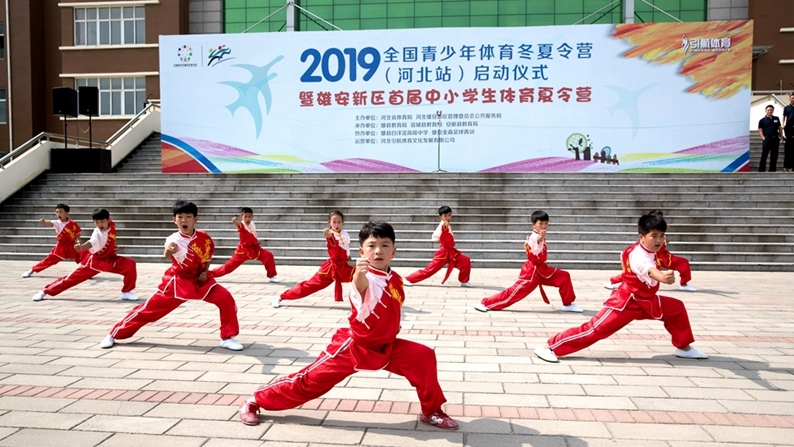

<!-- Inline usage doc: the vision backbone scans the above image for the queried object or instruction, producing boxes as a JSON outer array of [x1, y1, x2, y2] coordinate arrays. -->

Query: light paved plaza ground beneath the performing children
[[0, 261, 794, 447]]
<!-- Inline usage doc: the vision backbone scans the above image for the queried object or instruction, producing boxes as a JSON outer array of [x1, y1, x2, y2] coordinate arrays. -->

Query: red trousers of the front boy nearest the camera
[[254, 328, 447, 415]]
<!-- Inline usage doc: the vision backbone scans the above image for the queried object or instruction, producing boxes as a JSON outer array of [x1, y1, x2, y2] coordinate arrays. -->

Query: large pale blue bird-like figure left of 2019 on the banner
[[221, 55, 284, 138]]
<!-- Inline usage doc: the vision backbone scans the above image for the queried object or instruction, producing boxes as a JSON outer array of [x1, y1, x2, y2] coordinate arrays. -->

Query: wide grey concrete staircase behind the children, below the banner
[[0, 134, 794, 271]]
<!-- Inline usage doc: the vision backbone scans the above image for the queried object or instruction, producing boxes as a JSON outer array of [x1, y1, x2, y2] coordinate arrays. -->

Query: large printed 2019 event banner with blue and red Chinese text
[[160, 21, 753, 173]]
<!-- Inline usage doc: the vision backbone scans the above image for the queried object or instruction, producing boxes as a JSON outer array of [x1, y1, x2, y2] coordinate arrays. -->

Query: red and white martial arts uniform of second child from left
[[44, 220, 138, 296]]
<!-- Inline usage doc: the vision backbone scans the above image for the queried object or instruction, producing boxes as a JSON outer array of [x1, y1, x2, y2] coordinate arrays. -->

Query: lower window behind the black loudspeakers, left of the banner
[[75, 77, 146, 116]]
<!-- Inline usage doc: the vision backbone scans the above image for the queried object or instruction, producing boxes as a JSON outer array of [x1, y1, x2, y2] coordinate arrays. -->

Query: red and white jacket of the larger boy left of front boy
[[158, 230, 217, 300]]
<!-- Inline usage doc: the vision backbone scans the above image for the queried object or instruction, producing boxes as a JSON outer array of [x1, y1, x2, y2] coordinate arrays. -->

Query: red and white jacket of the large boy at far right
[[604, 241, 663, 320]]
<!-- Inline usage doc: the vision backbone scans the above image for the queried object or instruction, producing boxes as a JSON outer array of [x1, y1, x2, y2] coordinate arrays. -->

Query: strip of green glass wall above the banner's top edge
[[224, 0, 707, 33]]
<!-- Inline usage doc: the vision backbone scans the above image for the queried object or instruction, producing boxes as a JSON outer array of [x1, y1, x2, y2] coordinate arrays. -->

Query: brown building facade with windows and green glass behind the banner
[[0, 0, 768, 153]]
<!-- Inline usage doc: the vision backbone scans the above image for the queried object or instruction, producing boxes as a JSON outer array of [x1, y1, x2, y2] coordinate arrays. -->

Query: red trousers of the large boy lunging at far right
[[548, 296, 695, 356]]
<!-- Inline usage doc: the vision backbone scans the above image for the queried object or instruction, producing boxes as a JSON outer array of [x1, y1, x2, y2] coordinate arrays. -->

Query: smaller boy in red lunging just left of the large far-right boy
[[474, 211, 582, 312]]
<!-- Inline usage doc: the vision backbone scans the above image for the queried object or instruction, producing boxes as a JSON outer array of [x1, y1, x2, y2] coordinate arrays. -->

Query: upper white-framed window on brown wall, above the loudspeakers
[[74, 6, 146, 46]]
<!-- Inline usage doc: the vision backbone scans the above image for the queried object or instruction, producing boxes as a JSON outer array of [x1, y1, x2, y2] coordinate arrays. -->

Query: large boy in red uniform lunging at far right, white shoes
[[535, 215, 708, 363]]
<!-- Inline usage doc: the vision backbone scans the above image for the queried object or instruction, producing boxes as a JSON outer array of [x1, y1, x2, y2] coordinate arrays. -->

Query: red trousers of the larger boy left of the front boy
[[110, 284, 240, 340]]
